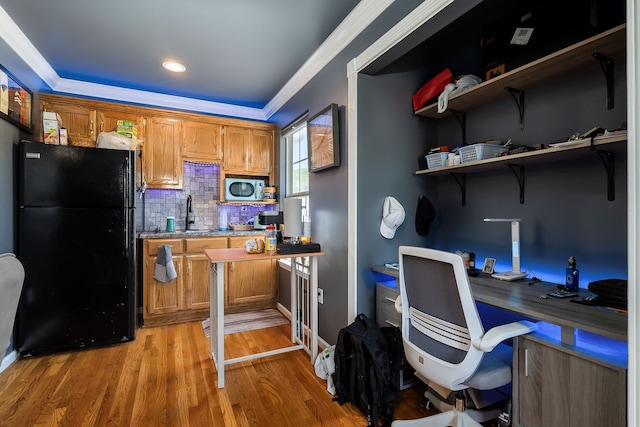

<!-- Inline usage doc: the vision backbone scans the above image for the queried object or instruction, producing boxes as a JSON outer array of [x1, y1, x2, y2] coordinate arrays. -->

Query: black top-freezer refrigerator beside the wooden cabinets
[[16, 142, 137, 356]]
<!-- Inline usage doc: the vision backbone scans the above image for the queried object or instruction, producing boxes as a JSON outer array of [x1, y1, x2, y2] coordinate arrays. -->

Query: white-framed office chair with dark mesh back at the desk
[[392, 246, 537, 427]]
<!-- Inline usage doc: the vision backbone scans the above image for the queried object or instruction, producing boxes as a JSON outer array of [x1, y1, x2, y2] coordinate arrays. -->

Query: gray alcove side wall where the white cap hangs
[[357, 72, 438, 318]]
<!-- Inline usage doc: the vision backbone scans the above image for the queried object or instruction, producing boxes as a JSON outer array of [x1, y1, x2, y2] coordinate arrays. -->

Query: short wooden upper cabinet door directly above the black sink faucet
[[182, 121, 222, 161]]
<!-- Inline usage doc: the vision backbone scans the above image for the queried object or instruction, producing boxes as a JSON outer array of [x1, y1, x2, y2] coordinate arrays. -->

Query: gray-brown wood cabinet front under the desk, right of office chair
[[513, 335, 626, 427]]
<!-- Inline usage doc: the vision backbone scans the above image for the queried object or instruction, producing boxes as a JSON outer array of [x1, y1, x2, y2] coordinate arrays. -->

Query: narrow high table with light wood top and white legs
[[204, 248, 324, 388]]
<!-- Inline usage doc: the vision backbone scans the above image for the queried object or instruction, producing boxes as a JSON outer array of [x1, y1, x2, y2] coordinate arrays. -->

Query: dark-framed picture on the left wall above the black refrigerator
[[0, 65, 33, 133]]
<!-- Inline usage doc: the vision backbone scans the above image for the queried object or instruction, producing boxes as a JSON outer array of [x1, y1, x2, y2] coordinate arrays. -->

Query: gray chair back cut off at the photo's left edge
[[0, 253, 24, 357]]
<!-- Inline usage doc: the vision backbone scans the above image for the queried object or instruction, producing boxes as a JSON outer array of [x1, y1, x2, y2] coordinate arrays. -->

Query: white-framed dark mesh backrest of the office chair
[[399, 246, 484, 390]]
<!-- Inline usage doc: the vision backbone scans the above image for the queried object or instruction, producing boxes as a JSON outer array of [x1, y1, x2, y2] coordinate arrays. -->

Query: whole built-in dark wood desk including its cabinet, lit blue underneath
[[372, 267, 627, 427]]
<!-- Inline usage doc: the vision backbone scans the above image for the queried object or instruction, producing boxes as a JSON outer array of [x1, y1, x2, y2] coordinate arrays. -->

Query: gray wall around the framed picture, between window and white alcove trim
[[269, 0, 422, 344]]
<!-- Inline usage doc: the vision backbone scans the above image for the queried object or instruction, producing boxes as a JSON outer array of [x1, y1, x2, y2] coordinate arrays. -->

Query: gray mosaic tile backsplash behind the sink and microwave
[[136, 162, 275, 231]]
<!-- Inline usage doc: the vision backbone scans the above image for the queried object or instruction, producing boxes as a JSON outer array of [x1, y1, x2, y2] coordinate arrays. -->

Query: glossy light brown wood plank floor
[[0, 321, 436, 427]]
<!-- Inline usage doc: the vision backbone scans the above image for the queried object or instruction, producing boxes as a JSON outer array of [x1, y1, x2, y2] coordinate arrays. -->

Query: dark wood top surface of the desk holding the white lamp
[[372, 266, 627, 345]]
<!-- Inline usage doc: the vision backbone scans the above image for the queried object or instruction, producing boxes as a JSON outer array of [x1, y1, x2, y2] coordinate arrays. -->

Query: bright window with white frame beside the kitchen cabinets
[[282, 114, 310, 235]]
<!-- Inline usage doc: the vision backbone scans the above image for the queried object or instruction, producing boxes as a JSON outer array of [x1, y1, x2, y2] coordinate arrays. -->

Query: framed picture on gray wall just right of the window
[[307, 104, 340, 172]]
